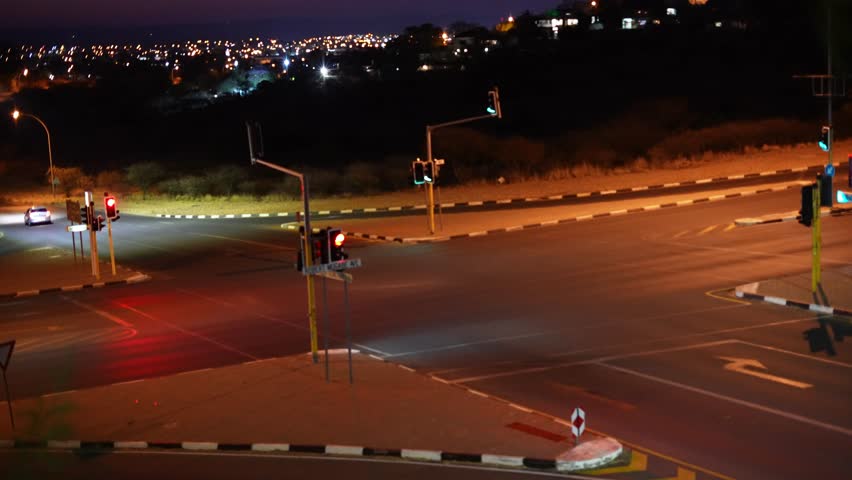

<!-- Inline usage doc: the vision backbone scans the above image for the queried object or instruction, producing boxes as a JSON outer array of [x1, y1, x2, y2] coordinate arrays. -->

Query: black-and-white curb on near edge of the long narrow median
[[342, 183, 799, 243]]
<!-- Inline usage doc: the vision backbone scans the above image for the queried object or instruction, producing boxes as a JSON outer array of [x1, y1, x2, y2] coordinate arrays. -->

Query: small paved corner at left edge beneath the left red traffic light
[[0, 244, 149, 298]]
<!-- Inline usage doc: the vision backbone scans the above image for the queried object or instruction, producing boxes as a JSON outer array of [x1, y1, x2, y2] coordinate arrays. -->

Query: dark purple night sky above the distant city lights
[[6, 0, 560, 38]]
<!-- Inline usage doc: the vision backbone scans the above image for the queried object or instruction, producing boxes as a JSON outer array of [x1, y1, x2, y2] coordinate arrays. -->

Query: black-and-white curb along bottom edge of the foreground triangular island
[[0, 438, 622, 472]]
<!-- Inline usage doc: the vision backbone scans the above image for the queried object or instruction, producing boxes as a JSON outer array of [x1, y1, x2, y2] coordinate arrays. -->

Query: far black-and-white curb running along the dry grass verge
[[153, 163, 824, 220]]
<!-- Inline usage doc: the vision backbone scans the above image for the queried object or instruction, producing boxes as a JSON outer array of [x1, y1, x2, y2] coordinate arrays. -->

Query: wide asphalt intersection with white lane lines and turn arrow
[[0, 184, 852, 479]]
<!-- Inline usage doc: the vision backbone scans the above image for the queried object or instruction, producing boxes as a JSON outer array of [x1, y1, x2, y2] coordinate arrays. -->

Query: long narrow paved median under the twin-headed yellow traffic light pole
[[302, 182, 800, 243]]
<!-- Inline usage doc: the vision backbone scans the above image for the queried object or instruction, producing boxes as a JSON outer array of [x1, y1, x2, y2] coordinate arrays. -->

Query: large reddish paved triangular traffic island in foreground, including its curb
[[0, 350, 623, 471]]
